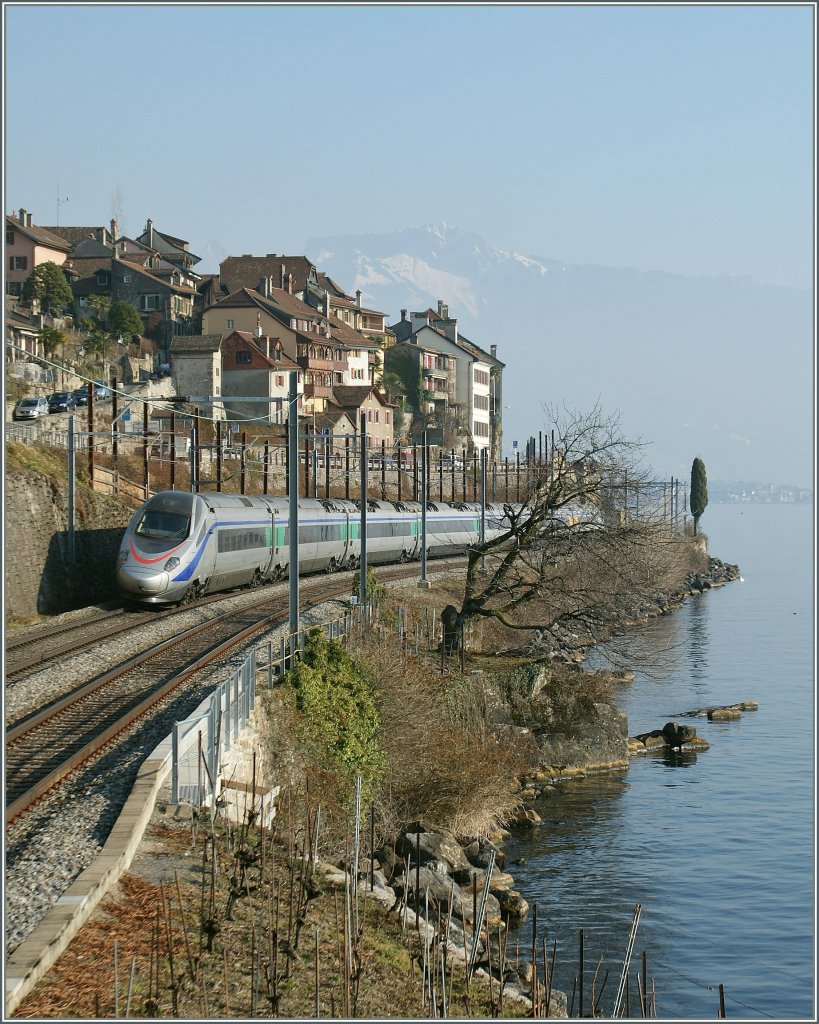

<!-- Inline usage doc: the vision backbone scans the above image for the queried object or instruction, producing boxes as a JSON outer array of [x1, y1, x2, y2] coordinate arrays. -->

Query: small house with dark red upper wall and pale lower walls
[[221, 331, 304, 429]]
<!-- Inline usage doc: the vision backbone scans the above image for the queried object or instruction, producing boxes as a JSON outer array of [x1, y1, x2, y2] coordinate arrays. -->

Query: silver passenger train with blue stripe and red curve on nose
[[117, 490, 509, 604]]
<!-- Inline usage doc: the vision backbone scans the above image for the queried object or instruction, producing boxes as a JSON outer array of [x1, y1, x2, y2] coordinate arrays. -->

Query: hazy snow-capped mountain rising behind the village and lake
[[304, 224, 813, 486]]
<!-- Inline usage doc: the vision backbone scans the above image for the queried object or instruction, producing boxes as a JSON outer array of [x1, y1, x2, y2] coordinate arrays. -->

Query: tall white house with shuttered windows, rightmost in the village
[[387, 301, 505, 459]]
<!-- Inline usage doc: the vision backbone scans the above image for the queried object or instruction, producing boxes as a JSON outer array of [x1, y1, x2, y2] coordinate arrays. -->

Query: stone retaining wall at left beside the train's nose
[[3, 469, 133, 618]]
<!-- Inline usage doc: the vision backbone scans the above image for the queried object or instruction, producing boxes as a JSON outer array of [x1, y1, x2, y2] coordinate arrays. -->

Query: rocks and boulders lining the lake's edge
[[317, 557, 758, 1017]]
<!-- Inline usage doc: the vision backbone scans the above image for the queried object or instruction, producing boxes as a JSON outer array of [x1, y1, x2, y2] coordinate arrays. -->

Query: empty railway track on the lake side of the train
[[5, 559, 454, 827]]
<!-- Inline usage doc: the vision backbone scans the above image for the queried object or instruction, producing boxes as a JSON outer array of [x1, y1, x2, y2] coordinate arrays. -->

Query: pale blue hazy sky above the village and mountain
[[4, 3, 815, 288]]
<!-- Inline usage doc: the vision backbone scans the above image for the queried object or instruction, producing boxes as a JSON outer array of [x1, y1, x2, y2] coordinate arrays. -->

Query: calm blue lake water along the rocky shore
[[505, 504, 815, 1020]]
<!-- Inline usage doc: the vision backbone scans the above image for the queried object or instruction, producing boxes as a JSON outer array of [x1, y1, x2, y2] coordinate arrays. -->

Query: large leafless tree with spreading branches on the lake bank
[[442, 404, 681, 649]]
